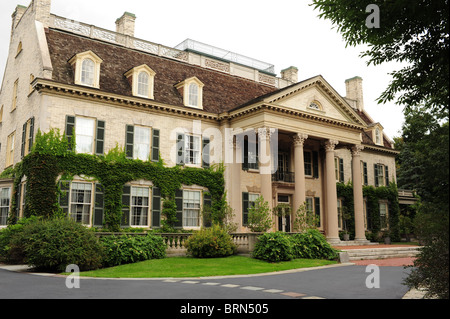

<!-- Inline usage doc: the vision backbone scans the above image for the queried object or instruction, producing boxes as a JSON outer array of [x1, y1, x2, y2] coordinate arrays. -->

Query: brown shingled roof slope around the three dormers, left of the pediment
[[47, 29, 277, 113]]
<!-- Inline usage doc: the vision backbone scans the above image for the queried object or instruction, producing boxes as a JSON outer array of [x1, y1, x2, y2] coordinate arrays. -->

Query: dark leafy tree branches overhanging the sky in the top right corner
[[312, 0, 449, 118]]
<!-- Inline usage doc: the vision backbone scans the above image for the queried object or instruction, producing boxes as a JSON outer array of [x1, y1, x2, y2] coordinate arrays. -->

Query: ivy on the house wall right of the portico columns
[[337, 182, 400, 241]]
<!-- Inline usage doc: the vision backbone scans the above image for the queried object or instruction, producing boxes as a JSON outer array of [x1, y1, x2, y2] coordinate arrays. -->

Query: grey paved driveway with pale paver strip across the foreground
[[0, 264, 414, 300]]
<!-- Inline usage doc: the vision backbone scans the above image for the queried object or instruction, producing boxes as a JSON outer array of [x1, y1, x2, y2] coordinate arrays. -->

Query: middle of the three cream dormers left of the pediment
[[125, 64, 156, 99]]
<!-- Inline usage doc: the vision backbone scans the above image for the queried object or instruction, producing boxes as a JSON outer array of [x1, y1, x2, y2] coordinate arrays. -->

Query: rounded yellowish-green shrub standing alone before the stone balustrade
[[185, 225, 237, 258]]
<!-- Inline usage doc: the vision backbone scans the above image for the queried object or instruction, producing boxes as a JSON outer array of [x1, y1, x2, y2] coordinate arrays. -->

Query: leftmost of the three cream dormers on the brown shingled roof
[[69, 51, 103, 88]]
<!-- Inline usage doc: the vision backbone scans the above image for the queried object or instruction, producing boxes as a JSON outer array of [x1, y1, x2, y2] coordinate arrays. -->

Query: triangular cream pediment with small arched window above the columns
[[264, 76, 364, 125]]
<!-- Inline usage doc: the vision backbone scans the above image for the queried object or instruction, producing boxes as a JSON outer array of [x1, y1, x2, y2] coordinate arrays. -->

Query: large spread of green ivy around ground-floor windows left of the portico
[[9, 130, 226, 231]]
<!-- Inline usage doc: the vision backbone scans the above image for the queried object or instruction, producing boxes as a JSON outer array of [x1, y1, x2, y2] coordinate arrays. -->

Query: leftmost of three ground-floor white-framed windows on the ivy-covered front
[[69, 182, 93, 225]]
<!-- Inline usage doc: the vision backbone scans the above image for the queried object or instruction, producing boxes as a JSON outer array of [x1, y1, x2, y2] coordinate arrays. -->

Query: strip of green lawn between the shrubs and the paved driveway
[[80, 256, 337, 278]]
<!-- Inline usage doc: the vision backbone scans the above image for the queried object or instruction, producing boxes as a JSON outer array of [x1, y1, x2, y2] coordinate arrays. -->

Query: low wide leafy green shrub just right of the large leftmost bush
[[101, 234, 166, 267]]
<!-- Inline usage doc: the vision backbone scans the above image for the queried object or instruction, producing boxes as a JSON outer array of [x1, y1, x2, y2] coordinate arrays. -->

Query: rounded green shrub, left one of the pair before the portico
[[253, 232, 293, 262]]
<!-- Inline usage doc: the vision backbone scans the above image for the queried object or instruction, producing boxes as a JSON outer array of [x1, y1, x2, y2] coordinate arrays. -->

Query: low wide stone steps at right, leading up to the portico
[[341, 246, 420, 261]]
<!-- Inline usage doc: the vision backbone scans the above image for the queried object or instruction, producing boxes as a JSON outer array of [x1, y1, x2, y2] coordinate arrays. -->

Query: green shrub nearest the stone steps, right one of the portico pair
[[290, 229, 338, 260]]
